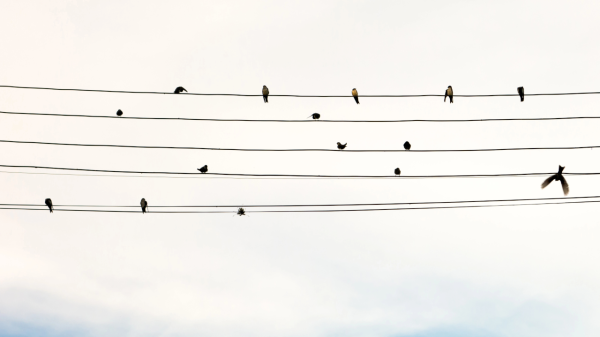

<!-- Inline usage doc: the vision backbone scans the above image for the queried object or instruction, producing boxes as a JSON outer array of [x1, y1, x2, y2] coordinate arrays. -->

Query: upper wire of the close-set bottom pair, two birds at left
[[0, 196, 600, 208]]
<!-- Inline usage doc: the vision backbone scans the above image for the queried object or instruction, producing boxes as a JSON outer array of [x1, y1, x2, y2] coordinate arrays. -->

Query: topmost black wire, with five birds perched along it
[[0, 85, 600, 98]]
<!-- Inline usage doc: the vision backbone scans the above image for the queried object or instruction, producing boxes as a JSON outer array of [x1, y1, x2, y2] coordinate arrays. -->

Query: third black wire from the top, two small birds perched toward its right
[[0, 140, 600, 153]]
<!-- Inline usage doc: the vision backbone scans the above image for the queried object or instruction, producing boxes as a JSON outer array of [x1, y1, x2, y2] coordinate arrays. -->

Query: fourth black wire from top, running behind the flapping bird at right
[[0, 164, 600, 179]]
